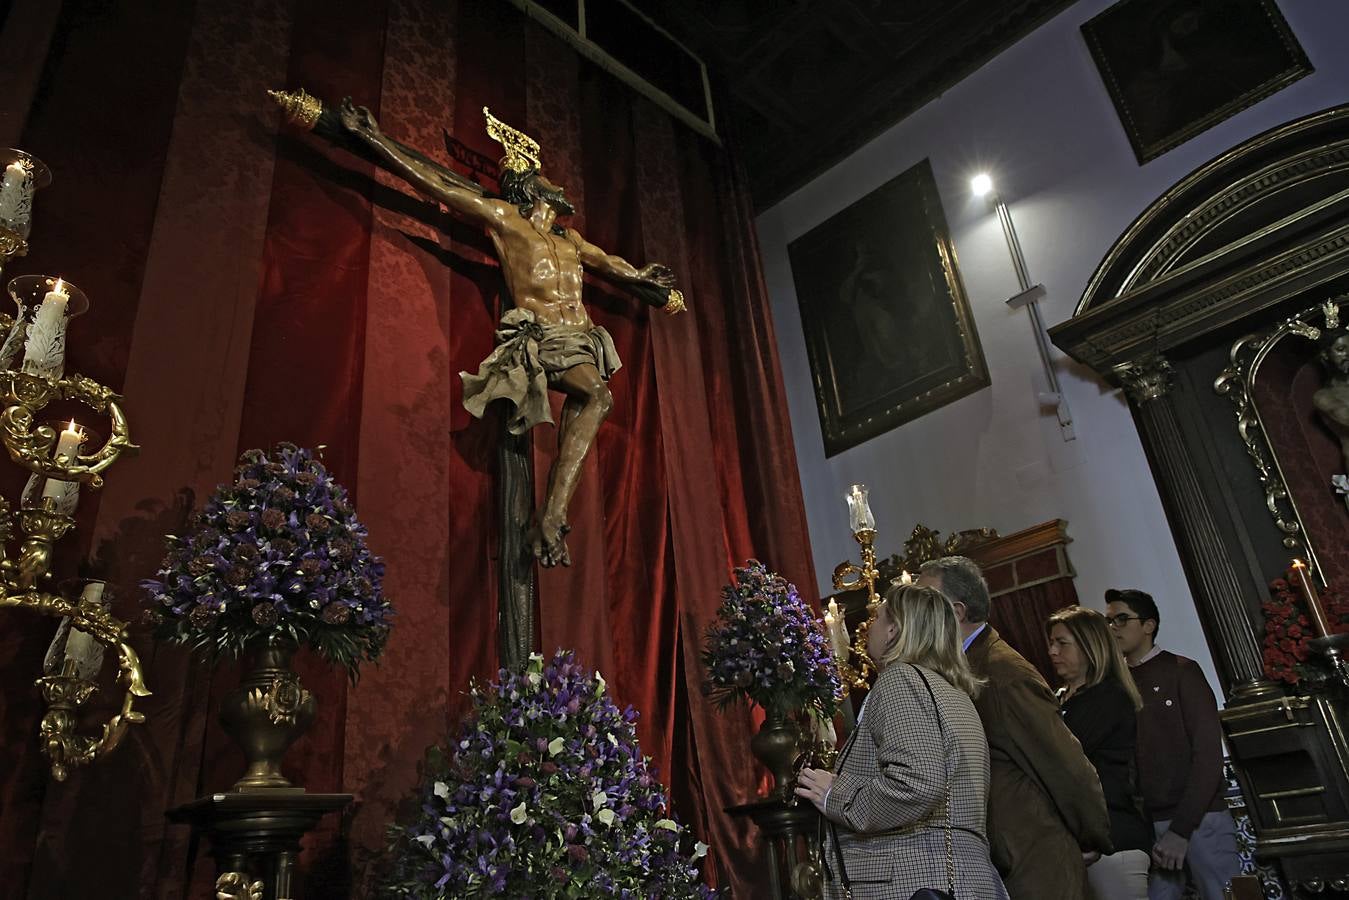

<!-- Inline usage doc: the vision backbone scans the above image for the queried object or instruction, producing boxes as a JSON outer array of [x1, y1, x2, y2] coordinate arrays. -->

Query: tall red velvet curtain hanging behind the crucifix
[[0, 0, 815, 897]]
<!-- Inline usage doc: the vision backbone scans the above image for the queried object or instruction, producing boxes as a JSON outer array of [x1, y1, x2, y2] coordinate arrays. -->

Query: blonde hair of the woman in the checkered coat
[[876, 584, 983, 698]]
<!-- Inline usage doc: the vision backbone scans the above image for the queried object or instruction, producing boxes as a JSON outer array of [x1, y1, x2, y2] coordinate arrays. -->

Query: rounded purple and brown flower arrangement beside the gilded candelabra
[[140, 444, 393, 679]]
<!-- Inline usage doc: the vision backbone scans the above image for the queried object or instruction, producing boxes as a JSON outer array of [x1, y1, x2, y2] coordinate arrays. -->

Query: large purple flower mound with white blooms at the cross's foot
[[383, 650, 716, 900]]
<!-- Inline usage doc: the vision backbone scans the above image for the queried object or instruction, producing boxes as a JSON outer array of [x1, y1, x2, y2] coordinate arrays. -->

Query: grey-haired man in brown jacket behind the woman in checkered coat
[[919, 556, 1113, 900]]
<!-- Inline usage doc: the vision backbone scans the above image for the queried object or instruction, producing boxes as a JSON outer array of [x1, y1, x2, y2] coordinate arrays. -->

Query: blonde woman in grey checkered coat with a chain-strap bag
[[796, 584, 1008, 900]]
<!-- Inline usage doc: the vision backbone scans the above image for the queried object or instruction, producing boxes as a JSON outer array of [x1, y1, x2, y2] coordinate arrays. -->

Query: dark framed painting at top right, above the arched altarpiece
[[1082, 0, 1313, 165]]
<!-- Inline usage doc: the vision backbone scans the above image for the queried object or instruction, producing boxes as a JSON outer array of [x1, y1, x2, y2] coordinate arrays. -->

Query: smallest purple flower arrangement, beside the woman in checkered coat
[[703, 560, 840, 719]]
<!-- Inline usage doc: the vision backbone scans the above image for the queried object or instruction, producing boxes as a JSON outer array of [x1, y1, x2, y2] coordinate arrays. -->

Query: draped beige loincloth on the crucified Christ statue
[[459, 309, 623, 434]]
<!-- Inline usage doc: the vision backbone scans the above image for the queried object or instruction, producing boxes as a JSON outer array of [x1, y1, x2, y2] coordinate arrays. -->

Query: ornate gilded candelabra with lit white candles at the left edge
[[0, 151, 150, 781]]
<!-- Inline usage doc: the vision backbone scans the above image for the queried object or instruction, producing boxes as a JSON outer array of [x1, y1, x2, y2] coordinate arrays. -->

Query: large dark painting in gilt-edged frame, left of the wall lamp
[[788, 159, 989, 456]]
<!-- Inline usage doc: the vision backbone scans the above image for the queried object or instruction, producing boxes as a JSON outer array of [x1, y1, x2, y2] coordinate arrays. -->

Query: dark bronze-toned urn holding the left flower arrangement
[[220, 638, 317, 791]]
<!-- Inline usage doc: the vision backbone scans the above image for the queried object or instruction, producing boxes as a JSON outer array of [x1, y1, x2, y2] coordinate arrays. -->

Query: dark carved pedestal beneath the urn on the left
[[167, 789, 352, 900]]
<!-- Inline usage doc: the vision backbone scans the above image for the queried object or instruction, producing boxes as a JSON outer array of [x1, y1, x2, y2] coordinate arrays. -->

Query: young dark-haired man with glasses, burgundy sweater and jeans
[[1105, 590, 1241, 900]]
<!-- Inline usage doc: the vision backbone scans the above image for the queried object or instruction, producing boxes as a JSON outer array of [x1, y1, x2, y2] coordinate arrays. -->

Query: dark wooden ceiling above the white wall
[[629, 0, 1072, 209]]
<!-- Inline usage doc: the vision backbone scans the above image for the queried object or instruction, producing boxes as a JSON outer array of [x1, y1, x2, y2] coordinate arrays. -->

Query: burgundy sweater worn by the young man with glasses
[[1129, 650, 1226, 838]]
